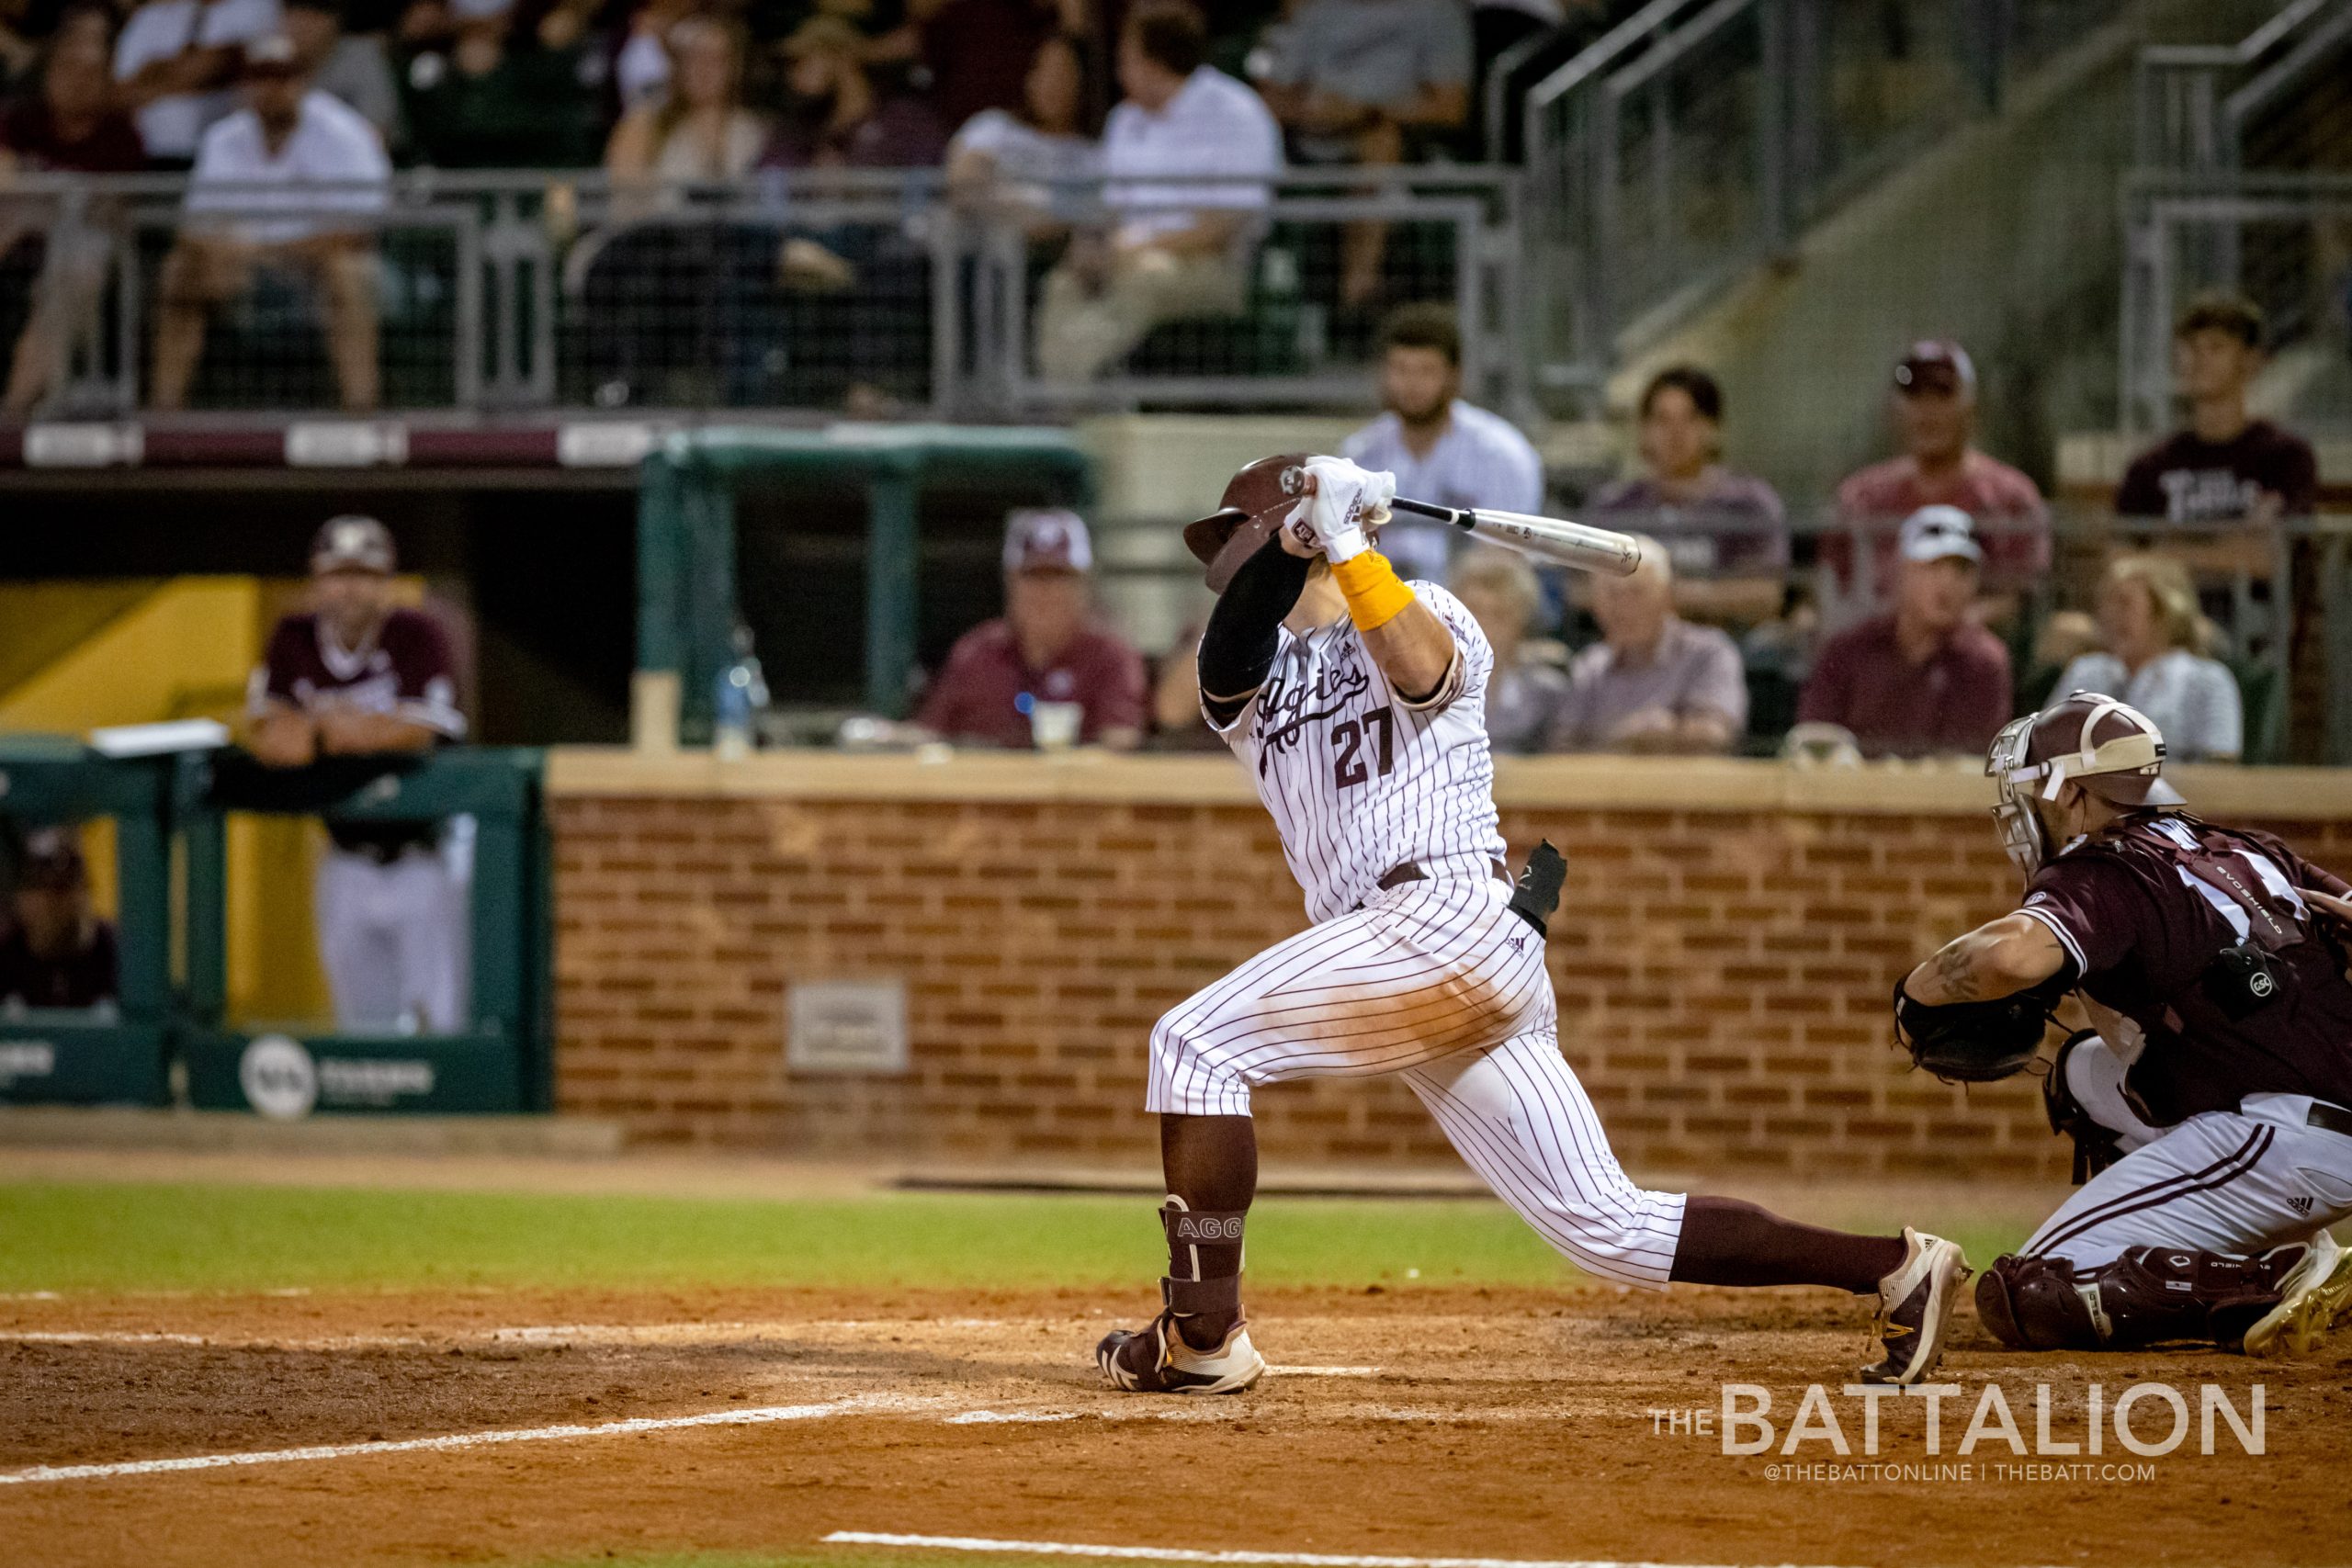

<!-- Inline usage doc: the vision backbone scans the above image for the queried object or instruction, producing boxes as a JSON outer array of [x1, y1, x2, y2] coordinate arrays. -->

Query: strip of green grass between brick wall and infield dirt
[[0, 1182, 2020, 1293]]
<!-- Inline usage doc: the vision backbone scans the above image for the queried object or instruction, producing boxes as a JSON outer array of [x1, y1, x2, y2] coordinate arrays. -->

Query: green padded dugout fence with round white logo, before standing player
[[174, 748, 555, 1117]]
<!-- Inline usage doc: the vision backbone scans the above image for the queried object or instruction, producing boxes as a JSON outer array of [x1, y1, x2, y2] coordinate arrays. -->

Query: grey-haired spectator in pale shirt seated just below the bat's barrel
[[1545, 538, 1747, 752]]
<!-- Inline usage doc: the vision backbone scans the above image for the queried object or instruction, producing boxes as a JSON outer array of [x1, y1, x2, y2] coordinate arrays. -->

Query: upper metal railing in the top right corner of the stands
[[2133, 0, 2352, 174]]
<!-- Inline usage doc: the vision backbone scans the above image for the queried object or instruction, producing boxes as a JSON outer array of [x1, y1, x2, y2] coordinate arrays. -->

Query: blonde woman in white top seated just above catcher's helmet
[[2049, 555, 2246, 761]]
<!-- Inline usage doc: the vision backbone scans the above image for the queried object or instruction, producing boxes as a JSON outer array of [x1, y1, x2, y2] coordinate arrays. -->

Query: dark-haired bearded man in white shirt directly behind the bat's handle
[[1340, 303, 1543, 583]]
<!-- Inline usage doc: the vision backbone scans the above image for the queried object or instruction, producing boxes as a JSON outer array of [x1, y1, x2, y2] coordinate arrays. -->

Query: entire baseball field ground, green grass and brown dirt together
[[0, 1152, 2352, 1568]]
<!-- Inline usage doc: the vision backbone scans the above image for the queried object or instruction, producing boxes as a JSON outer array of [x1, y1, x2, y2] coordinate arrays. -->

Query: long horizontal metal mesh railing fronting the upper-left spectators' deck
[[0, 167, 1524, 419]]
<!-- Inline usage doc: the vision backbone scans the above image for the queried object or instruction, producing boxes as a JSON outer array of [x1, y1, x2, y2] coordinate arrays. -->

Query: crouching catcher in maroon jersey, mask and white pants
[[1895, 691, 2352, 1354]]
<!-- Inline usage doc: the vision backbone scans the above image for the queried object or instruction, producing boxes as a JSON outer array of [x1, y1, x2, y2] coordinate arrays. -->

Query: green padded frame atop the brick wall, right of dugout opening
[[630, 425, 1093, 748]]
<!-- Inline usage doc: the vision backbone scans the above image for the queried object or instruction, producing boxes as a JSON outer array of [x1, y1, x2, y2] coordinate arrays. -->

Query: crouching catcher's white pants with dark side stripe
[[2025, 1039, 2352, 1269]]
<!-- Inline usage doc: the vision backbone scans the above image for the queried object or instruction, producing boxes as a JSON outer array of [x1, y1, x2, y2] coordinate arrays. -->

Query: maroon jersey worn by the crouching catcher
[[2023, 811, 2352, 1126]]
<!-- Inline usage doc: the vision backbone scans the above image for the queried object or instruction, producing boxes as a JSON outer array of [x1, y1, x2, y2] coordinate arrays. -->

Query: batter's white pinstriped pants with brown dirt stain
[[1146, 856, 1681, 1286]]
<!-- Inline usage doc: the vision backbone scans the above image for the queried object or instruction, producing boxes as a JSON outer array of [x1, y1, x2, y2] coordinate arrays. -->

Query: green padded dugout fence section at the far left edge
[[0, 736, 176, 1105]]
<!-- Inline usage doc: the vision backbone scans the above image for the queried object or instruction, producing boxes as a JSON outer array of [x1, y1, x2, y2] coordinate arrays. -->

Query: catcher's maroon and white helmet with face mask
[[1985, 691, 2188, 877]]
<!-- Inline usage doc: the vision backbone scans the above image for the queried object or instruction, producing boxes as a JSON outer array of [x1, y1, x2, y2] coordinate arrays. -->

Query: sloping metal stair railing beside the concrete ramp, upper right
[[1521, 0, 2131, 402]]
